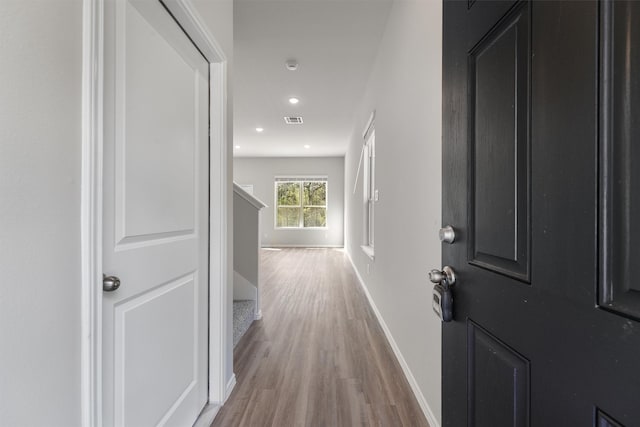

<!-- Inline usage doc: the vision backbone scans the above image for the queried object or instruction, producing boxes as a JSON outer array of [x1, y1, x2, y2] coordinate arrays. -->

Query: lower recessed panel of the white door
[[114, 274, 198, 426]]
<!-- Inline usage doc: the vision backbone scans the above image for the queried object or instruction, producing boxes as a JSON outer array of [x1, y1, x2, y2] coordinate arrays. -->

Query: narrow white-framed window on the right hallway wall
[[361, 112, 378, 259]]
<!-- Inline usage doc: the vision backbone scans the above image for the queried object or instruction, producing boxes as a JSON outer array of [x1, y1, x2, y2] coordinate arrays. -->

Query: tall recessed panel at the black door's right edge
[[598, 1, 640, 320]]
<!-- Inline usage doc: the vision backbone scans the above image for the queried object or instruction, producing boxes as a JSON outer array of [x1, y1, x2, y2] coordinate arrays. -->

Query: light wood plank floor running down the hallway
[[212, 249, 428, 427]]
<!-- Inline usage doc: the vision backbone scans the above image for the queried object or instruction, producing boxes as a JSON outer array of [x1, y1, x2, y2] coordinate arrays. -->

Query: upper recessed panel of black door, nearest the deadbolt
[[468, 3, 530, 282]]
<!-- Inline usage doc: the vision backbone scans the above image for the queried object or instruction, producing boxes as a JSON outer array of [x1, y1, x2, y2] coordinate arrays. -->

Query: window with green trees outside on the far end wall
[[275, 177, 327, 228]]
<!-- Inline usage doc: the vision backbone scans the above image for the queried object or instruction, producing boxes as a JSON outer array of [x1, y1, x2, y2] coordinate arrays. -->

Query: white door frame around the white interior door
[[81, 0, 233, 427]]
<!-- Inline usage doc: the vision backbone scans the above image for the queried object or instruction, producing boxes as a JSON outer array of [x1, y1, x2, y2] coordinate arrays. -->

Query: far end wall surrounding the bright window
[[234, 157, 344, 247]]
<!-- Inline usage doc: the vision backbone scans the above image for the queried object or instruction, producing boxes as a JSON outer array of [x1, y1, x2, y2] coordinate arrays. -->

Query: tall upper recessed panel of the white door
[[115, 0, 207, 243]]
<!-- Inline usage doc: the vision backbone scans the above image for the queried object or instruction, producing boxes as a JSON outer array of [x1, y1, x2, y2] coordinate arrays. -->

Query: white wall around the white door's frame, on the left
[[0, 0, 233, 427]]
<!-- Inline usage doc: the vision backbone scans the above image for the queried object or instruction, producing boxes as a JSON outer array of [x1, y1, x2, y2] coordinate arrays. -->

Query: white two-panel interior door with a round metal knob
[[103, 0, 209, 427]]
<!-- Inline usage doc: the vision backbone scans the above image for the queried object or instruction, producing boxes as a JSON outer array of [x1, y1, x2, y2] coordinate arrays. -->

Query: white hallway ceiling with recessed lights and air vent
[[233, 0, 391, 157]]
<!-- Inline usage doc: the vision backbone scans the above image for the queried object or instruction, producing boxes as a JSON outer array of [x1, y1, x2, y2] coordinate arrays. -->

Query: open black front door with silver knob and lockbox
[[442, 0, 640, 427]]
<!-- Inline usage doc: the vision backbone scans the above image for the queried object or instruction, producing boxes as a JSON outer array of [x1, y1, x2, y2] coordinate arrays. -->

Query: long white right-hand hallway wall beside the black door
[[345, 0, 442, 422]]
